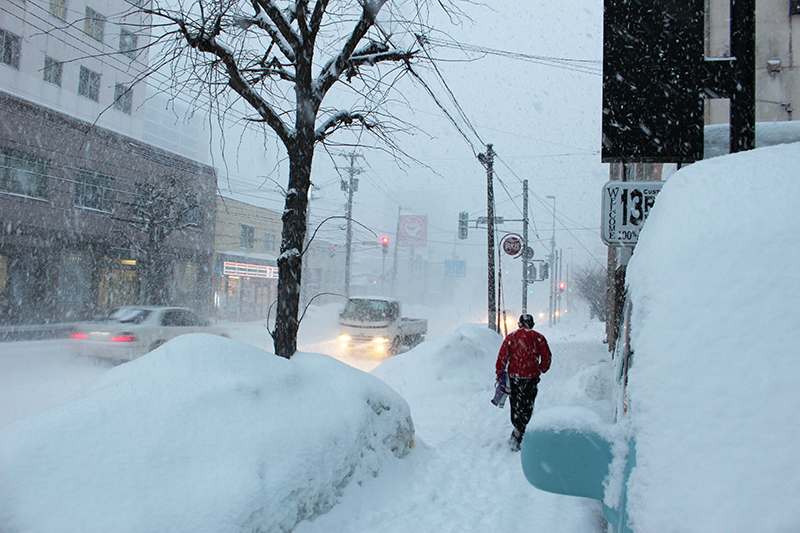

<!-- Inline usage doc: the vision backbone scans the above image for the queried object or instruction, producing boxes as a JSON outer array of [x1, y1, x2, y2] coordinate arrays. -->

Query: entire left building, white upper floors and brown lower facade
[[0, 0, 216, 325]]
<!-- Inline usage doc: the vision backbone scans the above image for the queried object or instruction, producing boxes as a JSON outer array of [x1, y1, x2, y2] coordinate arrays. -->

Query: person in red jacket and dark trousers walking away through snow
[[495, 314, 551, 451]]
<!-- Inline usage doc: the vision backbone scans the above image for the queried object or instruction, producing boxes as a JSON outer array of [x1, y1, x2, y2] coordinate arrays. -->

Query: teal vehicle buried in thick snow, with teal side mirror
[[521, 144, 800, 533]]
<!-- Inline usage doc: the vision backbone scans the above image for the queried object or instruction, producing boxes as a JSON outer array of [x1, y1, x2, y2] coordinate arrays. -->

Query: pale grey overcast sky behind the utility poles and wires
[[188, 0, 608, 314]]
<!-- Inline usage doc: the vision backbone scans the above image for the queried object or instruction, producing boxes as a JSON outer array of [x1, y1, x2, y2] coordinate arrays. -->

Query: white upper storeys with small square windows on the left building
[[0, 0, 150, 139]]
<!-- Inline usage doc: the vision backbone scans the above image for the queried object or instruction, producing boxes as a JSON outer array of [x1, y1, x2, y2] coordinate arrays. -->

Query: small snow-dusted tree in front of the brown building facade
[[121, 176, 202, 305]]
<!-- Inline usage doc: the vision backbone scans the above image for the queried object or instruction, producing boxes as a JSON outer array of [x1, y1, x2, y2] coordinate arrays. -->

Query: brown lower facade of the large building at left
[[0, 92, 216, 325]]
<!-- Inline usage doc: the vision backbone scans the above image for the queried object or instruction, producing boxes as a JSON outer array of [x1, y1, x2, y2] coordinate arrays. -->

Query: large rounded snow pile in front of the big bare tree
[[0, 334, 414, 533]]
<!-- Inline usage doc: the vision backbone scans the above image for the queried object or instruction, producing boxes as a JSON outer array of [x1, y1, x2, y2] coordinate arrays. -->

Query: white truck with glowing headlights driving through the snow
[[339, 296, 428, 356]]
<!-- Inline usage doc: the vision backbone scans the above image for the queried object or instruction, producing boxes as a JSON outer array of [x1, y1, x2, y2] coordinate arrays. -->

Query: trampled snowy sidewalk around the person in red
[[295, 318, 610, 533]]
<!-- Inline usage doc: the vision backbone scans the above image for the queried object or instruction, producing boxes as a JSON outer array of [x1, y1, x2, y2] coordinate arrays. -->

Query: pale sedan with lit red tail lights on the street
[[72, 306, 226, 361]]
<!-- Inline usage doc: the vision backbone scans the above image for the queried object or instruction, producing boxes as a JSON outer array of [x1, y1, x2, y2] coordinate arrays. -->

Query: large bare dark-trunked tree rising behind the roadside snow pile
[[130, 0, 460, 358]]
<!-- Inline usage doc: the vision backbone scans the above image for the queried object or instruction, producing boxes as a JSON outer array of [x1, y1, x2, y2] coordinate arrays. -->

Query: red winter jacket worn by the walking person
[[496, 328, 551, 379]]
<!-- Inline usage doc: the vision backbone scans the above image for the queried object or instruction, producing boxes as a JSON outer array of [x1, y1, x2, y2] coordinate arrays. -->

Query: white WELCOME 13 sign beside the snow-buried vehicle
[[601, 181, 664, 246]]
